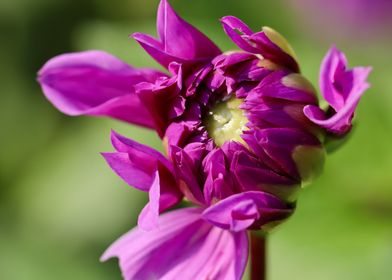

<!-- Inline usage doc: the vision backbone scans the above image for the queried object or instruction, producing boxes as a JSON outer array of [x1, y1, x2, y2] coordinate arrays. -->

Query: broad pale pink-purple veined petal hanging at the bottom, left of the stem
[[101, 208, 248, 280]]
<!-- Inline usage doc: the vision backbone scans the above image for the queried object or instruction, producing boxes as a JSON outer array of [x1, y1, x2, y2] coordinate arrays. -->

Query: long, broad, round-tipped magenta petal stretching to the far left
[[38, 51, 165, 128]]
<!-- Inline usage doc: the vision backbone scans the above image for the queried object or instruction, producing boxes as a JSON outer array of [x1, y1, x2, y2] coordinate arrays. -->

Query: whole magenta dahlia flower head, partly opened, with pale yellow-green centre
[[38, 0, 370, 280]]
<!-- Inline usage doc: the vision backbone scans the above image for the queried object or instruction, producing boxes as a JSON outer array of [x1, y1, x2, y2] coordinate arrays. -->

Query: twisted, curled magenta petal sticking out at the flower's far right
[[304, 46, 372, 135]]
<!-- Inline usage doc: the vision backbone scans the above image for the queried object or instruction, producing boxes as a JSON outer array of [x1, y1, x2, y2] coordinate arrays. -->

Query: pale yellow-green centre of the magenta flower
[[204, 96, 248, 146]]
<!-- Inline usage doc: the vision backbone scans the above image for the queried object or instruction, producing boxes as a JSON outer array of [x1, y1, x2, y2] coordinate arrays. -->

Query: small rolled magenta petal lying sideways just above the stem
[[203, 191, 292, 232]]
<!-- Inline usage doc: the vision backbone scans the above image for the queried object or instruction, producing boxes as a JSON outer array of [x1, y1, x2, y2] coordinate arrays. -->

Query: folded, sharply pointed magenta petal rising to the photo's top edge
[[133, 0, 221, 67]]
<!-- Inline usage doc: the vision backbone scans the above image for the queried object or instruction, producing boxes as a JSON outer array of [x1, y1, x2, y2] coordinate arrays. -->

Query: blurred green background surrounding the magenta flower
[[0, 0, 392, 280]]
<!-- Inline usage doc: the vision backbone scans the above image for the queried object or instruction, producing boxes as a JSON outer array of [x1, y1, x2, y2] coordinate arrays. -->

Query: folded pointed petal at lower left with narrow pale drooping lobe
[[102, 132, 182, 230]]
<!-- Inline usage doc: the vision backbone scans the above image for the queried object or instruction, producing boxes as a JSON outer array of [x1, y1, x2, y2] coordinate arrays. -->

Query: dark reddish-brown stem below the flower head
[[250, 232, 267, 280]]
